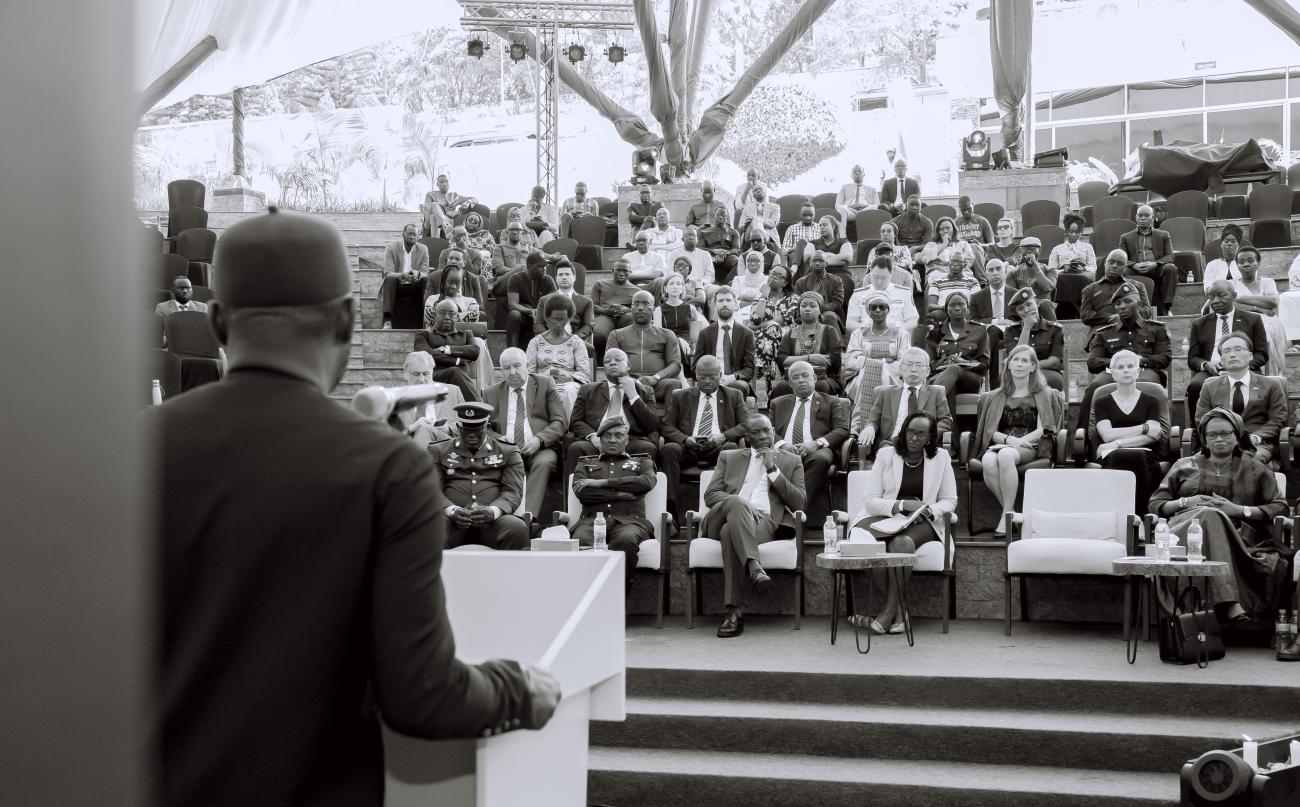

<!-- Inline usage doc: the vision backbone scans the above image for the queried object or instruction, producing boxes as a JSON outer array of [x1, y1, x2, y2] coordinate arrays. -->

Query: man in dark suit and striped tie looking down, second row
[[659, 353, 748, 512]]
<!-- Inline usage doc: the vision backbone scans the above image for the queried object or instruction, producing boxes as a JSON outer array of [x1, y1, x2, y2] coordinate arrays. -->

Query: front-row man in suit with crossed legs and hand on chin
[[701, 415, 806, 639]]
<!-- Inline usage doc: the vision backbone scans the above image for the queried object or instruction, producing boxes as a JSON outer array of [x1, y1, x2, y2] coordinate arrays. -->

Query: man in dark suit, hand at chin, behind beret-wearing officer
[[564, 347, 659, 477]]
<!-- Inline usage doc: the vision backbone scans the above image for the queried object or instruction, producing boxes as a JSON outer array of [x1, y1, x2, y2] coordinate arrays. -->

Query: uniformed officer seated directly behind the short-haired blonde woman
[[1079, 281, 1173, 429]]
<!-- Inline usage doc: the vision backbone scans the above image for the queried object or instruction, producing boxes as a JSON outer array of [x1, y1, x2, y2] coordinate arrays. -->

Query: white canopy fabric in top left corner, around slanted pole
[[135, 0, 460, 107]]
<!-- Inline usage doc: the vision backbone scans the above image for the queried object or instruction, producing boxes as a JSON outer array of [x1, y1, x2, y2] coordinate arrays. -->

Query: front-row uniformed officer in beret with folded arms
[[572, 417, 655, 583]]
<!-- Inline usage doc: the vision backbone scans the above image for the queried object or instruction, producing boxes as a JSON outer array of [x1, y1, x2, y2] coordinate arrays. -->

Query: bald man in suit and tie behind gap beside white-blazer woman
[[770, 361, 849, 526]]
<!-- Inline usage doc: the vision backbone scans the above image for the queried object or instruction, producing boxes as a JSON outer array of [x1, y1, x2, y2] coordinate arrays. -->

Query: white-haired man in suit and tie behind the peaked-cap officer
[[484, 347, 568, 515]]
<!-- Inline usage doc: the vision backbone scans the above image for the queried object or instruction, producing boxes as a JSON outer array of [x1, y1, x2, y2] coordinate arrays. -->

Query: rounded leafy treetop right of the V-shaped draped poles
[[718, 84, 845, 183]]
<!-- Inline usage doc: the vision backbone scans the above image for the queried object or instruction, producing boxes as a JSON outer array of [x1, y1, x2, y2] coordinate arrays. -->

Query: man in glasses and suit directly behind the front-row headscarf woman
[[1193, 331, 1287, 463]]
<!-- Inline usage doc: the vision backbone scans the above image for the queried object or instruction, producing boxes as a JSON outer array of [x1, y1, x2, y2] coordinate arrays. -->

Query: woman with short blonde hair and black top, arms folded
[[1087, 350, 1169, 516]]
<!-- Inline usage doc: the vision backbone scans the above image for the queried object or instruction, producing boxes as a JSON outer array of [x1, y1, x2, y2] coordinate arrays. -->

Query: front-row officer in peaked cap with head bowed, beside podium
[[429, 402, 528, 550]]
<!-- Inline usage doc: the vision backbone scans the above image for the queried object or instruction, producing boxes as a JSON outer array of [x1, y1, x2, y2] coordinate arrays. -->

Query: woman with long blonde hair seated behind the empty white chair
[[971, 344, 1065, 535]]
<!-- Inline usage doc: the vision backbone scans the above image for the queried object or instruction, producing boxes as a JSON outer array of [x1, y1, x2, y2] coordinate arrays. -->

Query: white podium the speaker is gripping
[[384, 550, 627, 807]]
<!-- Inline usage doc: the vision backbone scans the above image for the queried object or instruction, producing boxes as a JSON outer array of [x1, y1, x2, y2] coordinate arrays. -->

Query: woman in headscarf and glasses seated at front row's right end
[[1151, 407, 1295, 624]]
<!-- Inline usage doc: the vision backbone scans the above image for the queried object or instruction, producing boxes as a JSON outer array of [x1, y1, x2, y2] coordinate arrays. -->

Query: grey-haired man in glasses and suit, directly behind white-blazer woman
[[849, 347, 953, 468]]
